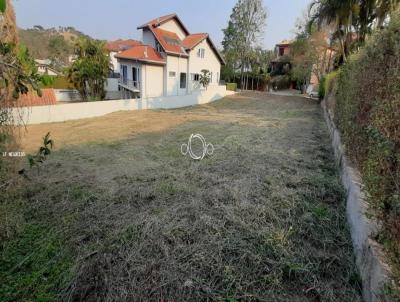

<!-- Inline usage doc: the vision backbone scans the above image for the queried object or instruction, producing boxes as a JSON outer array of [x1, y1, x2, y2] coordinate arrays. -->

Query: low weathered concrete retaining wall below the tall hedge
[[322, 101, 390, 302]]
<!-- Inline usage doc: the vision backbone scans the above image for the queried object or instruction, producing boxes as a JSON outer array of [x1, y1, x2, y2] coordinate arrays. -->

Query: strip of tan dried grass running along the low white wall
[[16, 96, 284, 152]]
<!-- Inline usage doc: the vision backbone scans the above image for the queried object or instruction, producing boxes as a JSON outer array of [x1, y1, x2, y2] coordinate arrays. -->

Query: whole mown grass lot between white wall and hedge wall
[[0, 94, 361, 302]]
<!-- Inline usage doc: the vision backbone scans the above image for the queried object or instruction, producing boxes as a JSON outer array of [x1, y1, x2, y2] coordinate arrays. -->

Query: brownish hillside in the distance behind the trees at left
[[18, 25, 88, 67]]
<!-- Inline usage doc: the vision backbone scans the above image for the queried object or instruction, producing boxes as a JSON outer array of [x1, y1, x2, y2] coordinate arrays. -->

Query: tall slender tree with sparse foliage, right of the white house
[[222, 0, 267, 88]]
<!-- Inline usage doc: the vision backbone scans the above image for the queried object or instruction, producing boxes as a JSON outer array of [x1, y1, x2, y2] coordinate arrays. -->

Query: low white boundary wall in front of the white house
[[14, 86, 233, 125]]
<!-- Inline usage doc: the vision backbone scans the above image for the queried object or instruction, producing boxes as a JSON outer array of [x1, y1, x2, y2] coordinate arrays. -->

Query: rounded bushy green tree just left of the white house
[[67, 38, 111, 101]]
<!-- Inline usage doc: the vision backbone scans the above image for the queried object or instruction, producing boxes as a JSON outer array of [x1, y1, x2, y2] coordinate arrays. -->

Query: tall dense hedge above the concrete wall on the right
[[330, 7, 400, 294]]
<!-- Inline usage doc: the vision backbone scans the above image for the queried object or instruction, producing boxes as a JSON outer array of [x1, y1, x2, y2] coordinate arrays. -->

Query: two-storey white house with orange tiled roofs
[[115, 14, 225, 98]]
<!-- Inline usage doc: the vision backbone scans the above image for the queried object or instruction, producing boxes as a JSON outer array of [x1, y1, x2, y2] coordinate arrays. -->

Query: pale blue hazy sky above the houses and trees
[[12, 0, 310, 49]]
